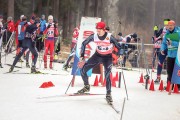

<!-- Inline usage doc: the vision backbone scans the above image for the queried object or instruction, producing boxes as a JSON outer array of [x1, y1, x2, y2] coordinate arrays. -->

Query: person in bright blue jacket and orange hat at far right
[[161, 20, 180, 87]]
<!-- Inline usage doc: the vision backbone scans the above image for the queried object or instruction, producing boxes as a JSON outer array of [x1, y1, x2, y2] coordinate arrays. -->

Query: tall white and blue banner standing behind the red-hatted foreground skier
[[71, 17, 101, 76]]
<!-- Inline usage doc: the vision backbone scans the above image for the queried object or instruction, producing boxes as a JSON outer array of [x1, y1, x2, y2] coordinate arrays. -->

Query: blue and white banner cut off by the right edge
[[171, 42, 180, 84]]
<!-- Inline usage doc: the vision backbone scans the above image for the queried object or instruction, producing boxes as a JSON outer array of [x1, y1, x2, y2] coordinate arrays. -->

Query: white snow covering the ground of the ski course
[[0, 54, 180, 120]]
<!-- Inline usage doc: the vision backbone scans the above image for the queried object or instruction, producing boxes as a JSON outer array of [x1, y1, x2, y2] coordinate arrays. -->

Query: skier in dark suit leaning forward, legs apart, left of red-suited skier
[[9, 18, 40, 73]]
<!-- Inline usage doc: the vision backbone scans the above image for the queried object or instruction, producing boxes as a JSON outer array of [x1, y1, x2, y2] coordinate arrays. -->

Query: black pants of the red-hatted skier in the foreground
[[81, 53, 112, 93]]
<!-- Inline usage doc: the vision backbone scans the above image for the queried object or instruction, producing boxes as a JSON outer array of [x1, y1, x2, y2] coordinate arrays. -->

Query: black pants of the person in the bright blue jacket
[[167, 57, 176, 82]]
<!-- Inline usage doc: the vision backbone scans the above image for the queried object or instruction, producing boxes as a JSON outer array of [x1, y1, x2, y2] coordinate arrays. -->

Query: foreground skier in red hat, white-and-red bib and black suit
[[78, 22, 120, 103]]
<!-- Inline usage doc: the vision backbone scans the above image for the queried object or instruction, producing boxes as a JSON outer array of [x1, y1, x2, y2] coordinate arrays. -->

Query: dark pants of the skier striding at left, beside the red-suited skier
[[13, 39, 38, 66]]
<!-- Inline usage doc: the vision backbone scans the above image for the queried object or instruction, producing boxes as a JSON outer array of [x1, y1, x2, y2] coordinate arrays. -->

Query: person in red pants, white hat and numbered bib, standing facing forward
[[43, 15, 58, 69]]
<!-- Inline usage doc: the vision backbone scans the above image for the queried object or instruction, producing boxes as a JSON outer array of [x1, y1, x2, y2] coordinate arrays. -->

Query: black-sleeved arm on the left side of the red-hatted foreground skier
[[80, 34, 94, 57]]
